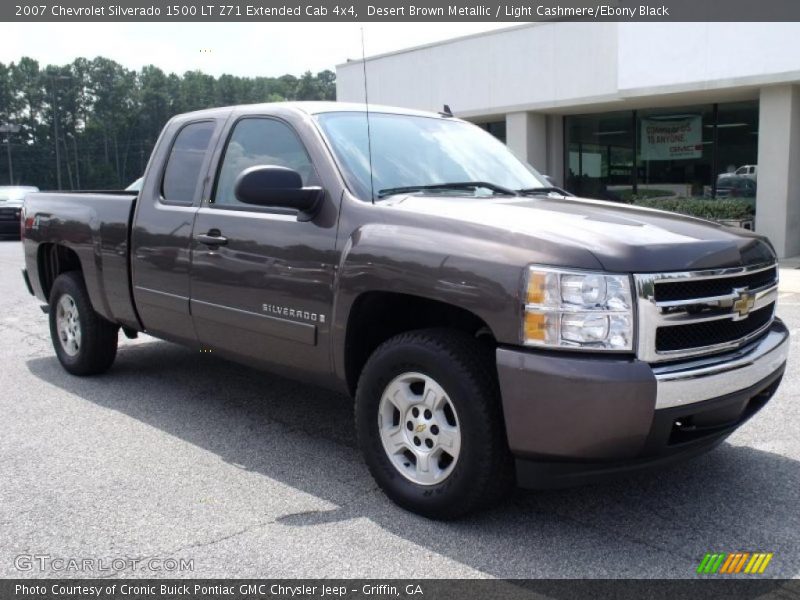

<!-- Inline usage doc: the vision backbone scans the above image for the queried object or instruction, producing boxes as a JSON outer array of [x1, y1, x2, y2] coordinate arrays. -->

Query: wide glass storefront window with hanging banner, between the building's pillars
[[564, 100, 758, 202]]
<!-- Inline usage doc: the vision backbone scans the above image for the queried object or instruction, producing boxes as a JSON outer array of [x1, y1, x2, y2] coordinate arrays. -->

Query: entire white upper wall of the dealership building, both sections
[[336, 22, 800, 118]]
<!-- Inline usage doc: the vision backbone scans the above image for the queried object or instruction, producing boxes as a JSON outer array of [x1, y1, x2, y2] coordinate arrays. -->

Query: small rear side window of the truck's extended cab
[[161, 121, 214, 204]]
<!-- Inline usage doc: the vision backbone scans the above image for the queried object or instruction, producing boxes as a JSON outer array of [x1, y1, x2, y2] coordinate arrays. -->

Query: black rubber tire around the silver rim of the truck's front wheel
[[355, 329, 514, 520]]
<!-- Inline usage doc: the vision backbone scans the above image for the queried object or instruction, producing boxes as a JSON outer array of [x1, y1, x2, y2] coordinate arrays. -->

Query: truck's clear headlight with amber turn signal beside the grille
[[522, 267, 633, 351]]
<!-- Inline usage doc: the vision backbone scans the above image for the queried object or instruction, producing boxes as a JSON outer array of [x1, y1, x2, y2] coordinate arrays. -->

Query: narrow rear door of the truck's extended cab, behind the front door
[[131, 115, 225, 344]]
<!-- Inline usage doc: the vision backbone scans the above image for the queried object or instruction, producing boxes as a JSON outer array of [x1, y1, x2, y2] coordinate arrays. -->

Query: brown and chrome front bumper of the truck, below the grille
[[497, 319, 789, 488]]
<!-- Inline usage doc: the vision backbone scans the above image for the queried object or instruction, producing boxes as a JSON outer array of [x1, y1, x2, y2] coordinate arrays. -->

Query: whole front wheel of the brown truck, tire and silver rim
[[356, 329, 513, 519]]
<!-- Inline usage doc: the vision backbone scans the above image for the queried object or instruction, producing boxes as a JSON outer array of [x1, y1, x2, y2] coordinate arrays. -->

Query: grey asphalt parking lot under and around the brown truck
[[0, 241, 800, 578]]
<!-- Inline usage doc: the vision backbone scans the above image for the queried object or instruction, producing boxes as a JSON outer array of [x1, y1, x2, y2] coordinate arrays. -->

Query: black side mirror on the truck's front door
[[233, 165, 325, 221]]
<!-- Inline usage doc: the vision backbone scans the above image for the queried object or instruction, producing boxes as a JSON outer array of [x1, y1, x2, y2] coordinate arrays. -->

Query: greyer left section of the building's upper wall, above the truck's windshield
[[336, 23, 617, 116]]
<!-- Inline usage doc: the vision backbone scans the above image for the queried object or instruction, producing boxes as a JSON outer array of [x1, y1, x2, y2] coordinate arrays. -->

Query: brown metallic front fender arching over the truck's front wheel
[[332, 223, 530, 377]]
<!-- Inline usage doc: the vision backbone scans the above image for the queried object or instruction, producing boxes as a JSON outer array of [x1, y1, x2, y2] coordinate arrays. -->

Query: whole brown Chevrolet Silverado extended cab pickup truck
[[21, 103, 788, 518]]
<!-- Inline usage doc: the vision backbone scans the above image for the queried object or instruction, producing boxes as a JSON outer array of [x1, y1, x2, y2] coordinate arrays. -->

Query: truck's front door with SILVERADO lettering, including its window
[[191, 110, 338, 374]]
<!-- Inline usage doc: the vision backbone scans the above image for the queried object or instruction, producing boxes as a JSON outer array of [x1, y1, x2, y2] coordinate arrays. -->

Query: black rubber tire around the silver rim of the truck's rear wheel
[[49, 271, 119, 375]]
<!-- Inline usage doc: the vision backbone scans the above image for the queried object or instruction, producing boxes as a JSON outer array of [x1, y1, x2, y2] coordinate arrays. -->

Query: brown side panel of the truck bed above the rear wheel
[[23, 191, 138, 327]]
